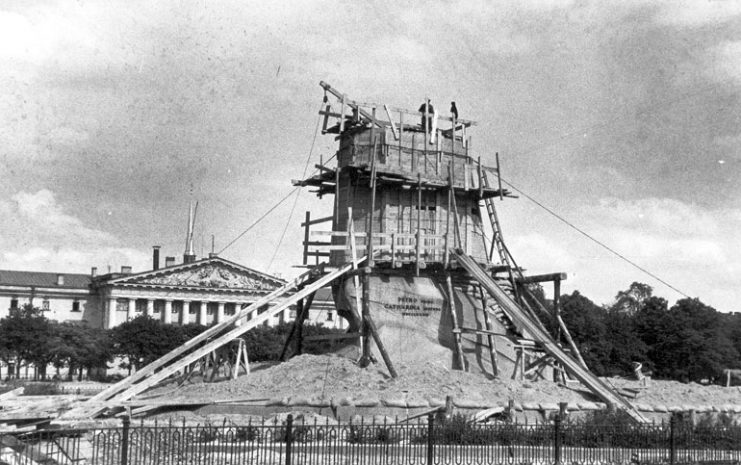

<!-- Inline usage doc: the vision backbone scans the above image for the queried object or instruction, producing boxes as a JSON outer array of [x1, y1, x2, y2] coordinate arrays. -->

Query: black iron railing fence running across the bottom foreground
[[0, 415, 741, 465]]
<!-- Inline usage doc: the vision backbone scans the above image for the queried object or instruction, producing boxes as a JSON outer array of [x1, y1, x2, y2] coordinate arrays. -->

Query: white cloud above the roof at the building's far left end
[[0, 189, 149, 272]]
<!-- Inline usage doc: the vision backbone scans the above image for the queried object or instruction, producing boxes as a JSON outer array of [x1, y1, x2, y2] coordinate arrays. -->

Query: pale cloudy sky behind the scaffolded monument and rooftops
[[0, 0, 741, 311]]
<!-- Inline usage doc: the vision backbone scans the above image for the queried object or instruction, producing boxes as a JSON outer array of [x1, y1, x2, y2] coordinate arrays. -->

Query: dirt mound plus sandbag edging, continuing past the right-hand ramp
[[140, 355, 741, 421]]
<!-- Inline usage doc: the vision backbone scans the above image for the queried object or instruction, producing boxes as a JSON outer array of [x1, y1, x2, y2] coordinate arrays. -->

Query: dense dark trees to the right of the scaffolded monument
[[561, 283, 741, 382]]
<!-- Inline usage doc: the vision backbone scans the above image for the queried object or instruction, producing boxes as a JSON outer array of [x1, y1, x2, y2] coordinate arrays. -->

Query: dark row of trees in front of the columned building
[[0, 305, 346, 380]]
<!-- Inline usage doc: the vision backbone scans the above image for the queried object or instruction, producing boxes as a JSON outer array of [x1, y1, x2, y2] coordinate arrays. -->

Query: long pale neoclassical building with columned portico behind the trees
[[0, 246, 344, 328]]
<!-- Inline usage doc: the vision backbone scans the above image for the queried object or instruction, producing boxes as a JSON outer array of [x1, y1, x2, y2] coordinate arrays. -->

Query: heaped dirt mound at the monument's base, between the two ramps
[[159, 355, 589, 405]]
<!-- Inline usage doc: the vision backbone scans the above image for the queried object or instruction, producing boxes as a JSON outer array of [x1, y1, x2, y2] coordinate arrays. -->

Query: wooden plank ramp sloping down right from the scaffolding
[[451, 250, 647, 423]]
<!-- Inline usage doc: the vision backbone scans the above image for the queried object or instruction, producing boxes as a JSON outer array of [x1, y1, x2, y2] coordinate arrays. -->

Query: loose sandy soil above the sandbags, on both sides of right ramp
[[150, 355, 741, 406]]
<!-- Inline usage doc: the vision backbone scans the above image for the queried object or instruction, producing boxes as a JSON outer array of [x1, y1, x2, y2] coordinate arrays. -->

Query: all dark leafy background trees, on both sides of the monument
[[0, 283, 741, 381]]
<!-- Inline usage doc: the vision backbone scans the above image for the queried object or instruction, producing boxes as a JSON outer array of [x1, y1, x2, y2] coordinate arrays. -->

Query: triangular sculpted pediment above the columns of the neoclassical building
[[108, 257, 283, 291]]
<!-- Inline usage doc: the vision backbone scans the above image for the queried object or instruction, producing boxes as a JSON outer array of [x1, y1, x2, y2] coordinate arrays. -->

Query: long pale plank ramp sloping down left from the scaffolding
[[61, 257, 366, 419]]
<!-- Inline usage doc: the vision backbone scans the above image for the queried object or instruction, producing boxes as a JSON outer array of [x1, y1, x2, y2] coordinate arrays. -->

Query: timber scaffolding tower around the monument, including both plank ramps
[[68, 82, 645, 421]]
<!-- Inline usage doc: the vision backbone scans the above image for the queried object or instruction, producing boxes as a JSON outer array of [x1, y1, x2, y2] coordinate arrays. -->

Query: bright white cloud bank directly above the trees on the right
[[508, 198, 741, 311]]
